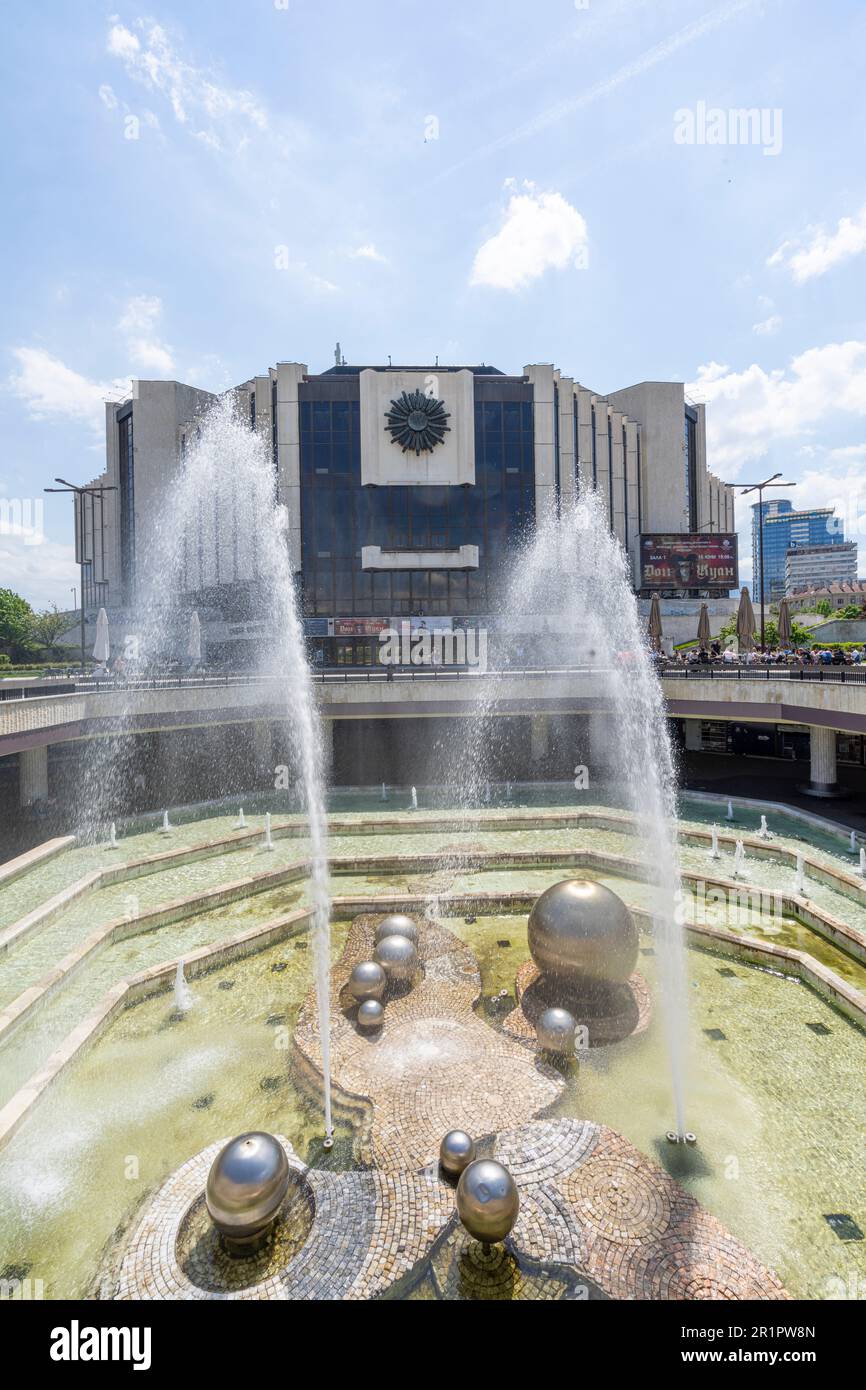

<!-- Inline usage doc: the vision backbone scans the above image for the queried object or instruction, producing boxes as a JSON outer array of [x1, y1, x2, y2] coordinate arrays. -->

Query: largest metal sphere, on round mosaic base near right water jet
[[528, 878, 638, 984]]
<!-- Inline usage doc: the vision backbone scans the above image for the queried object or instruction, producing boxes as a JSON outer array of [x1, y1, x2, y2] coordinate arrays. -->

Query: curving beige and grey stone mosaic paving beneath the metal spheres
[[114, 916, 787, 1301]]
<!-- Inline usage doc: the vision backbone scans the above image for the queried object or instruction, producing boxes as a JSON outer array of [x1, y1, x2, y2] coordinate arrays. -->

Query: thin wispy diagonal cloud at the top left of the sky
[[107, 19, 268, 150]]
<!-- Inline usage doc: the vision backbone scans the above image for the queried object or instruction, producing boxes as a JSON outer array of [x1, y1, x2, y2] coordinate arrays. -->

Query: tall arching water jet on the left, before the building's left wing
[[122, 398, 334, 1145]]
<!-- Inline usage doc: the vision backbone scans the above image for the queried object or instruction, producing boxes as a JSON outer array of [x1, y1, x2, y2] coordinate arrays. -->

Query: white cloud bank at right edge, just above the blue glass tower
[[687, 341, 866, 475]]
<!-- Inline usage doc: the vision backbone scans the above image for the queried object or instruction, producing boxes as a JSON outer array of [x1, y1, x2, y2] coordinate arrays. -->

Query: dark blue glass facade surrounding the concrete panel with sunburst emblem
[[299, 373, 535, 617]]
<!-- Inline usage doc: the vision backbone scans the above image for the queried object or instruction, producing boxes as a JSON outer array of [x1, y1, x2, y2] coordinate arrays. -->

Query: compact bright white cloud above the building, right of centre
[[470, 181, 587, 291]]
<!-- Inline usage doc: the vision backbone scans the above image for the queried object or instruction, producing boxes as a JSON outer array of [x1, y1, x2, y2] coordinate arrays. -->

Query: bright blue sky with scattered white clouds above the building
[[0, 0, 866, 609]]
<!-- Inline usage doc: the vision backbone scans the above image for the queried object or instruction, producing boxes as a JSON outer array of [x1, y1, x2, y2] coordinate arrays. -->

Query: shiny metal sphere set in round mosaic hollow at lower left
[[204, 1130, 289, 1254]]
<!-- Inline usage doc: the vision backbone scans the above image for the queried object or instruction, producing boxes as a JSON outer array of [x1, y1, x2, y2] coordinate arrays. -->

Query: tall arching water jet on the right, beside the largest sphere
[[461, 492, 687, 1134]]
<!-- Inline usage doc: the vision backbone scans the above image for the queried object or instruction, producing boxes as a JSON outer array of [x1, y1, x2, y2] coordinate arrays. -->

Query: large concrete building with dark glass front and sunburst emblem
[[77, 354, 734, 660]]
